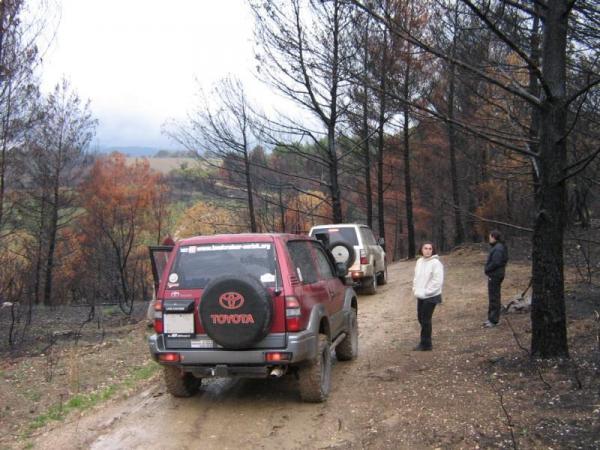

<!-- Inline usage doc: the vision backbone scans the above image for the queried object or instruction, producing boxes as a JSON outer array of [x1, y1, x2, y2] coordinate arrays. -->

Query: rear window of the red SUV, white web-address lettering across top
[[167, 242, 281, 289]]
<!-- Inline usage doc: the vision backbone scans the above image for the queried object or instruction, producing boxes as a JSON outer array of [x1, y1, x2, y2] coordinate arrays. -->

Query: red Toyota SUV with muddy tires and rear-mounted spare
[[149, 234, 358, 402]]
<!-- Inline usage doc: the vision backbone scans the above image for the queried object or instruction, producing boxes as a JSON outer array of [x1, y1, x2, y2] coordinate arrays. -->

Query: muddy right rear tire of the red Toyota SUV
[[298, 334, 331, 403]]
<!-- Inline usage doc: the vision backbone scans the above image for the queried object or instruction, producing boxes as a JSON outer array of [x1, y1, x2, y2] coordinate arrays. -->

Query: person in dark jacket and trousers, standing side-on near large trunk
[[483, 230, 508, 328]]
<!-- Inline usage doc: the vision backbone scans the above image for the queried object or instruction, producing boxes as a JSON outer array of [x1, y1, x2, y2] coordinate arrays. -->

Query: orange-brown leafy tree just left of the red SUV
[[75, 153, 170, 311]]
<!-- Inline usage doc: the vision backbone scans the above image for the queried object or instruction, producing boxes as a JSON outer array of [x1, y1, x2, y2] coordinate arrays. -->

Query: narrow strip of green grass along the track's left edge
[[23, 361, 159, 438]]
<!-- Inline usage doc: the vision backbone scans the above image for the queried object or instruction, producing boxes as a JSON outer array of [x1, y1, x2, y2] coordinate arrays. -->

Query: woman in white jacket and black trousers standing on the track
[[413, 242, 444, 351]]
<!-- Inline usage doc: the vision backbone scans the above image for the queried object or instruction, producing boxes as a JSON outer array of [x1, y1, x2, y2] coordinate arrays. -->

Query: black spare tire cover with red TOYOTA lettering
[[199, 275, 273, 349]]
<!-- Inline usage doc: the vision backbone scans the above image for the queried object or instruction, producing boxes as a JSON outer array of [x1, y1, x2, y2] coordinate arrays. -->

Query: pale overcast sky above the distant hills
[[42, 0, 264, 148]]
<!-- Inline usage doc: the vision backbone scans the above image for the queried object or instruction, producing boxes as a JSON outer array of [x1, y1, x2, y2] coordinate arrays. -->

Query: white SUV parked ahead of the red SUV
[[309, 224, 387, 294]]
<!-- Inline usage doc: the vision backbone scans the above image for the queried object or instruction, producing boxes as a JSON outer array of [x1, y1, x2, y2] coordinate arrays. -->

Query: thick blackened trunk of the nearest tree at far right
[[531, 0, 569, 358]]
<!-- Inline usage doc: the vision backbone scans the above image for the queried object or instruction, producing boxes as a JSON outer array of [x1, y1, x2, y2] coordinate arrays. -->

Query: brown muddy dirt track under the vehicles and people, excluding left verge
[[29, 253, 593, 450]]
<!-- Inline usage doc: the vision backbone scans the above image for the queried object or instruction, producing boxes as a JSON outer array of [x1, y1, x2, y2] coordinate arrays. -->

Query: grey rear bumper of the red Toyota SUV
[[148, 330, 317, 370]]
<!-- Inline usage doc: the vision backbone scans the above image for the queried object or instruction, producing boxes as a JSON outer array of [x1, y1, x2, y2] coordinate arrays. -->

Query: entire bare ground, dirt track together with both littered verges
[[0, 248, 600, 449]]
